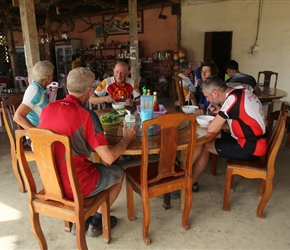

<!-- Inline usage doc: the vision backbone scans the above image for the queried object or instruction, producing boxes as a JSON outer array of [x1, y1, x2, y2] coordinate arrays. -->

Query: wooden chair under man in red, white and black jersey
[[223, 103, 288, 218]]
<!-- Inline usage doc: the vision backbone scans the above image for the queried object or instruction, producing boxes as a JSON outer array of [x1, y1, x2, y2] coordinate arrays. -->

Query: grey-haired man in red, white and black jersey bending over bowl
[[193, 76, 268, 191]]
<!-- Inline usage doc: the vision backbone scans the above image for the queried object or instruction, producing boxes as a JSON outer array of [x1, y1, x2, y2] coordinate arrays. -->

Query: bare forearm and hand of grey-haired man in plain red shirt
[[95, 122, 137, 164]]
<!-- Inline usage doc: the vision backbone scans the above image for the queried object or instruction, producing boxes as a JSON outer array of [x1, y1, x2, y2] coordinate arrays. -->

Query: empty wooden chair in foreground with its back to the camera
[[125, 113, 196, 245]]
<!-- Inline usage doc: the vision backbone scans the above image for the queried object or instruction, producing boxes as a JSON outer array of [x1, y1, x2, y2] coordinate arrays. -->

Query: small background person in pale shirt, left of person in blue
[[178, 62, 197, 105]]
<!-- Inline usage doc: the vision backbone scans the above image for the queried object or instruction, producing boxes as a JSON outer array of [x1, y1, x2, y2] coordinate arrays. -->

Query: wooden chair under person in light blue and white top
[[1, 98, 34, 193]]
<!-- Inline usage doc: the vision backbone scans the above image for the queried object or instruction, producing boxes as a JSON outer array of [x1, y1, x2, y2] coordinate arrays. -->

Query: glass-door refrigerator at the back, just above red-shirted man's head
[[55, 39, 81, 78]]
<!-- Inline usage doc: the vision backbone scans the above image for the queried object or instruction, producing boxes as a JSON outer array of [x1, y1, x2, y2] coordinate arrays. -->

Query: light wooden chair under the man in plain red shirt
[[15, 128, 111, 249]]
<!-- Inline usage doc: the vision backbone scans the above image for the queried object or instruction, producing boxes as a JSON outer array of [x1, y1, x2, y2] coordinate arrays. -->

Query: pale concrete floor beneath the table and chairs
[[0, 96, 290, 249]]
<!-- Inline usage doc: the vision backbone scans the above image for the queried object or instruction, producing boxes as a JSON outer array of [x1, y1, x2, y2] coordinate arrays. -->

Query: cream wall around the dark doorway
[[181, 0, 290, 101]]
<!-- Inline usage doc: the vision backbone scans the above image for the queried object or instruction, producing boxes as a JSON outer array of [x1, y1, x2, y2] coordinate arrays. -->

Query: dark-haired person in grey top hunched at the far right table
[[226, 60, 261, 95]]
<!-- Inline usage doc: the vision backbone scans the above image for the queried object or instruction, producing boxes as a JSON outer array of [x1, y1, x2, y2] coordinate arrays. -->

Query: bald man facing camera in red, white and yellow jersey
[[89, 62, 140, 107]]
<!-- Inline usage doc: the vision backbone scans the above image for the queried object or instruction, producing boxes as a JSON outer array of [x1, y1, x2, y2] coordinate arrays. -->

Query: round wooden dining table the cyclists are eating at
[[93, 107, 216, 208]]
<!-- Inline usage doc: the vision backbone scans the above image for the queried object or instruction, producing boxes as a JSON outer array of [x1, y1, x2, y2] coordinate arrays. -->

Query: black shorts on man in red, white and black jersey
[[214, 131, 259, 161]]
